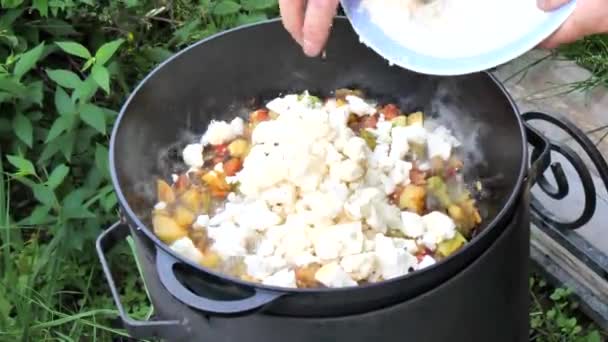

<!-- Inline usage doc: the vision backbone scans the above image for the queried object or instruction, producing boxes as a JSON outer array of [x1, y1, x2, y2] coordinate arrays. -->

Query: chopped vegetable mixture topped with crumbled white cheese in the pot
[[153, 89, 481, 288]]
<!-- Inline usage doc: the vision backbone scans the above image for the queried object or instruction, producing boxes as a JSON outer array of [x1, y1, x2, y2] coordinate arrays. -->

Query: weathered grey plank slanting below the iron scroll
[[530, 224, 608, 331]]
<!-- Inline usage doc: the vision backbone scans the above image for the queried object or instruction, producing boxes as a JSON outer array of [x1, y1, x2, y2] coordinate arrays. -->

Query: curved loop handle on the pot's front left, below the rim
[[156, 248, 286, 315]]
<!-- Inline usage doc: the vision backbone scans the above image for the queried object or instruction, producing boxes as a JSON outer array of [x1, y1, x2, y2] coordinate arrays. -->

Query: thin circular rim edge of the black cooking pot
[[109, 16, 528, 294]]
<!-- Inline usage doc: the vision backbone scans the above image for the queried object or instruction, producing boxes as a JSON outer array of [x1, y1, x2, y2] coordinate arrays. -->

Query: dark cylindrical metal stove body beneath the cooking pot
[[113, 192, 530, 342]]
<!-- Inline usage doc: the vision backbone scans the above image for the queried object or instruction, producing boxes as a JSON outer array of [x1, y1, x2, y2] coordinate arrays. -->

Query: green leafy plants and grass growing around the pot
[[0, 0, 608, 342]]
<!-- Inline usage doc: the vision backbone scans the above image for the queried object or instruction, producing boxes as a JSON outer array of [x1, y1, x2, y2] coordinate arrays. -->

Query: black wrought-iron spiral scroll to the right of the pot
[[522, 112, 608, 229]]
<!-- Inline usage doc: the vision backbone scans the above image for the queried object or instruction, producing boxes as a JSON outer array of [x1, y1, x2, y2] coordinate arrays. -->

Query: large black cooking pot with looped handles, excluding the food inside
[[104, 18, 549, 317]]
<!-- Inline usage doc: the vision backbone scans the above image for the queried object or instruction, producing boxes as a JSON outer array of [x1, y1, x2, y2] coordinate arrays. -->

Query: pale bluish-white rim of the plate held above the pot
[[341, 0, 576, 76]]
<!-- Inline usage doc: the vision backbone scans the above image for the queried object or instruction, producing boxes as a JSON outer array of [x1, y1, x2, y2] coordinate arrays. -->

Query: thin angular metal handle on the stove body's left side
[[96, 222, 183, 339]]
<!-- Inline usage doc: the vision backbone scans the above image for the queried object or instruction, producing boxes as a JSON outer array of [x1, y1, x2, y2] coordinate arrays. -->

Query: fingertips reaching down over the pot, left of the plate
[[279, 0, 339, 57]]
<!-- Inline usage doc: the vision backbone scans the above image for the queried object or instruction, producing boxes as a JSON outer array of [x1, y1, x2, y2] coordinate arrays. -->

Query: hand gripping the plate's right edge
[[537, 0, 608, 49]]
